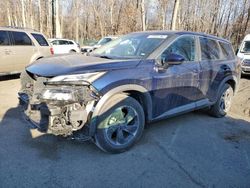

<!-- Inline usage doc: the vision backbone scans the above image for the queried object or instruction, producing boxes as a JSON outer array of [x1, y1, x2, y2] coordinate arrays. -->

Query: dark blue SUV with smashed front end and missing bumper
[[19, 31, 241, 153]]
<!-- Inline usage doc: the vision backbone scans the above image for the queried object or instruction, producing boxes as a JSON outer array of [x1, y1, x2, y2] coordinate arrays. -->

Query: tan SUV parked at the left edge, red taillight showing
[[0, 27, 53, 75]]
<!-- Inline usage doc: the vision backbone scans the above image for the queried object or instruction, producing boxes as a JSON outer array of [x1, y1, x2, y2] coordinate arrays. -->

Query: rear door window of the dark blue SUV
[[200, 38, 220, 60]]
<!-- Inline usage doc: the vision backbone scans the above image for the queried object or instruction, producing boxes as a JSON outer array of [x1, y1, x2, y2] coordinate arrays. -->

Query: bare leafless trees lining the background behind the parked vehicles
[[0, 0, 250, 47]]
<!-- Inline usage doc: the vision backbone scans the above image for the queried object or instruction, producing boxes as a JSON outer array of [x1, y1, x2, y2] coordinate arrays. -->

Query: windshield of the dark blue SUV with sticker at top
[[92, 33, 167, 59]]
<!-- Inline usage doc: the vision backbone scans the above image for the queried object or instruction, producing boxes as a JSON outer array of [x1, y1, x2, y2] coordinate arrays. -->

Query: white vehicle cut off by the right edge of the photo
[[237, 34, 250, 75]]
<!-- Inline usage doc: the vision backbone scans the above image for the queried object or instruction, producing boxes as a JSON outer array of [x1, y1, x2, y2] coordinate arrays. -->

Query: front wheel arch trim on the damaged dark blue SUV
[[89, 84, 152, 136]]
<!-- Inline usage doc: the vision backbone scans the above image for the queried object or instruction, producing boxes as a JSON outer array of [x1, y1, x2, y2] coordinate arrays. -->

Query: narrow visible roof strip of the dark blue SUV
[[131, 31, 231, 43]]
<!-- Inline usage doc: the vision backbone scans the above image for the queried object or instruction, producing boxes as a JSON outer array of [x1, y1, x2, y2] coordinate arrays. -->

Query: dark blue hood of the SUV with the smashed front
[[26, 54, 140, 77]]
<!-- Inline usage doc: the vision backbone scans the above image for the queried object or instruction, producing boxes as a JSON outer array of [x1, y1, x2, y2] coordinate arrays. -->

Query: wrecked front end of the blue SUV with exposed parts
[[18, 71, 101, 136]]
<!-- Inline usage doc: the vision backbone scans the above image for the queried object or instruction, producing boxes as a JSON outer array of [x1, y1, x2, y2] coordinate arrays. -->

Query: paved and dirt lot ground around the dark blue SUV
[[0, 75, 250, 187]]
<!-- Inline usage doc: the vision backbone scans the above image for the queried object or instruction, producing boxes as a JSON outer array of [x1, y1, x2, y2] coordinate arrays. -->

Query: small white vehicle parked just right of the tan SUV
[[49, 39, 80, 54]]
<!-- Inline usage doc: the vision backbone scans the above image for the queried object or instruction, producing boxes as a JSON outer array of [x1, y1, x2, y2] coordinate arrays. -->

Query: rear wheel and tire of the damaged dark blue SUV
[[209, 84, 233, 118]]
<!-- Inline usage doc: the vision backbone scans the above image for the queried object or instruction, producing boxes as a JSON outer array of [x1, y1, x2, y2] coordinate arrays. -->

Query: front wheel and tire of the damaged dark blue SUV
[[95, 94, 145, 153]]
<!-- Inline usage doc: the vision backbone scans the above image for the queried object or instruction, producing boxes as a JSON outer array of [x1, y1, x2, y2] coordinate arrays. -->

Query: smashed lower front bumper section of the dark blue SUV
[[19, 90, 92, 136]]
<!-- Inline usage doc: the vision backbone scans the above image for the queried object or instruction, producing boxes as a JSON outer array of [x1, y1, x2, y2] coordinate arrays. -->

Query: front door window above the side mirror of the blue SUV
[[162, 36, 195, 61]]
